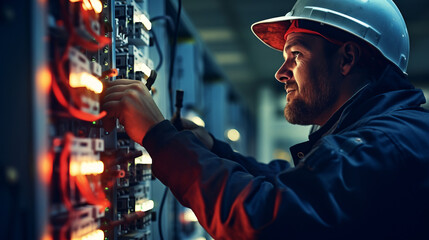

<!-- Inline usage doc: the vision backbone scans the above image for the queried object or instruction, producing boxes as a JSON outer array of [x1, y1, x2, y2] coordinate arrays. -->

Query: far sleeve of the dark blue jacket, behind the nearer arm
[[211, 136, 290, 178]]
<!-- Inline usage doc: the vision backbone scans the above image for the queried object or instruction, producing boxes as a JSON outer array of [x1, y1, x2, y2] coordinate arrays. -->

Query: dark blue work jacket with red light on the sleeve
[[143, 67, 429, 239]]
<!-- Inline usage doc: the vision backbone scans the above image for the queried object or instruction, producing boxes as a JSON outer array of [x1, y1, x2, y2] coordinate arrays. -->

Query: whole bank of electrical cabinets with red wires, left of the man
[[0, 0, 254, 240]]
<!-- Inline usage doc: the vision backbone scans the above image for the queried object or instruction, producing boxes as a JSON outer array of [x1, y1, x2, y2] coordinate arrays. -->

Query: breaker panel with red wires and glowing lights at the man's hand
[[47, 0, 156, 240]]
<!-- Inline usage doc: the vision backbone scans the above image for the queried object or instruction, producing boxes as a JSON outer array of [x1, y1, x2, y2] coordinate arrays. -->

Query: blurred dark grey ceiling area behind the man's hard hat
[[183, 0, 429, 106]]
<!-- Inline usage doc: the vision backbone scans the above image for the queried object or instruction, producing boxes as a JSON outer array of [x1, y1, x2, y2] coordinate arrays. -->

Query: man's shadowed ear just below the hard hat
[[340, 42, 362, 76]]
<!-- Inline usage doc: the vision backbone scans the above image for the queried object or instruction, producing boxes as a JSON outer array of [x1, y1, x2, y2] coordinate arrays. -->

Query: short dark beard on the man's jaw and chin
[[284, 79, 338, 125]]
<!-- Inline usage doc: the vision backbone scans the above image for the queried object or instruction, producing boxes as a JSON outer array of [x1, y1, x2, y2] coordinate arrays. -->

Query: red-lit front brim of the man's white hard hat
[[251, 16, 302, 51]]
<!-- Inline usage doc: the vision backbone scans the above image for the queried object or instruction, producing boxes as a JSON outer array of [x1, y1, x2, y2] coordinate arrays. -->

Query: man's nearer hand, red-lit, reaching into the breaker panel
[[101, 79, 164, 144]]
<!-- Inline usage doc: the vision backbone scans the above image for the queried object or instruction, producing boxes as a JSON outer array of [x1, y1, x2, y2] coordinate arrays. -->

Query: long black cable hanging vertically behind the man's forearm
[[158, 0, 182, 240]]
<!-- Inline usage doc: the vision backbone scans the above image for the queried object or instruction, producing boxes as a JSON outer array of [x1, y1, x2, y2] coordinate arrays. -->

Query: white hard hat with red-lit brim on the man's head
[[251, 0, 410, 74]]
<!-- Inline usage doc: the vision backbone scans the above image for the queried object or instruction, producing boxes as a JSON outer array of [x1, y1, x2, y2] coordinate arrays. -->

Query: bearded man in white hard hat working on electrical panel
[[103, 0, 429, 239]]
